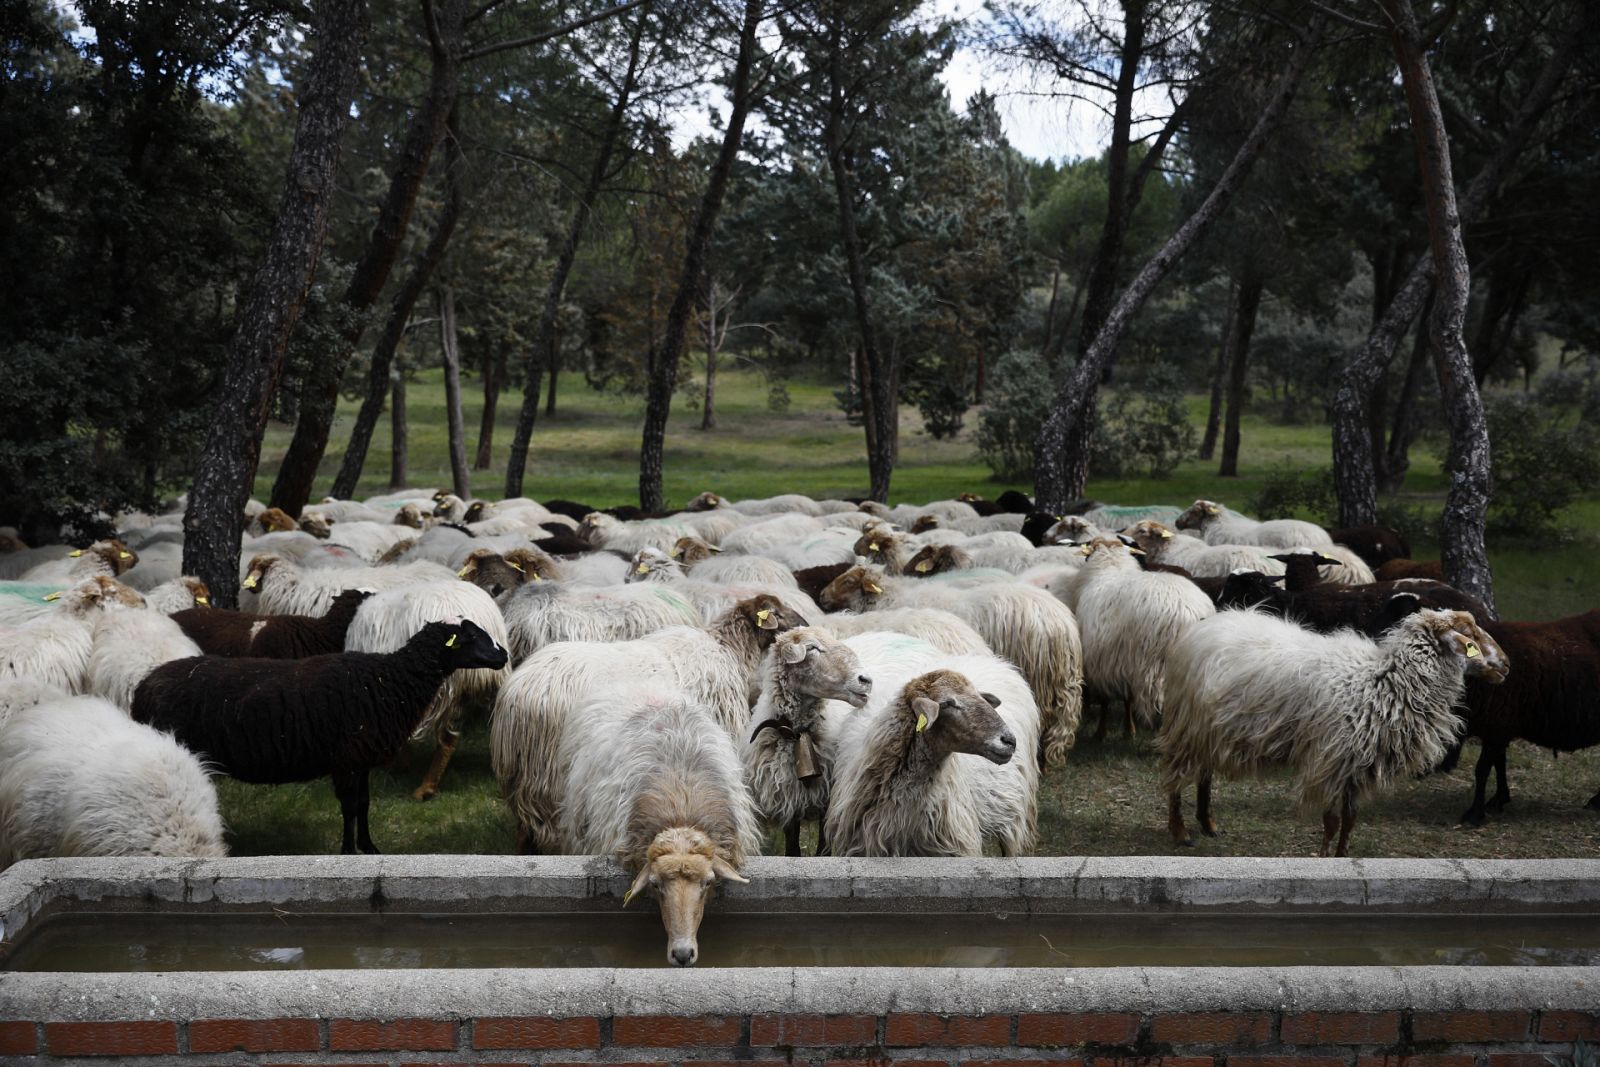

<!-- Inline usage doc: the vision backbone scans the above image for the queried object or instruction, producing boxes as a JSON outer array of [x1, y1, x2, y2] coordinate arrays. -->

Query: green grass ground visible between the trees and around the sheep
[[219, 363, 1600, 857]]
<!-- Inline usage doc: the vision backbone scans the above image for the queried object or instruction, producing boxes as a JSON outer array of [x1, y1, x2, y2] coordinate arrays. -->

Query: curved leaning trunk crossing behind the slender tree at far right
[[1331, 3, 1574, 526]]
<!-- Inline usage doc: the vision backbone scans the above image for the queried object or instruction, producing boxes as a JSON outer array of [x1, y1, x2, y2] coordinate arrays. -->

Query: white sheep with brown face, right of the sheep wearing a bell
[[824, 659, 1038, 856]]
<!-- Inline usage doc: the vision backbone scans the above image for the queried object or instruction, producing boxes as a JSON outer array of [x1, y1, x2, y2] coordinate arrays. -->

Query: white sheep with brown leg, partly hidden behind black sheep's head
[[344, 579, 510, 800]]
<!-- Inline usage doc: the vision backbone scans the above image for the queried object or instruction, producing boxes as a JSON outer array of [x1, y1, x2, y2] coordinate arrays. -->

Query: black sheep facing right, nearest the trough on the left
[[133, 619, 506, 854]]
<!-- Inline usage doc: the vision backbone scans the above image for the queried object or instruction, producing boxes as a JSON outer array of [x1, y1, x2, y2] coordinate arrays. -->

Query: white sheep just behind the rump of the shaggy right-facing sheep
[[1077, 537, 1216, 733]]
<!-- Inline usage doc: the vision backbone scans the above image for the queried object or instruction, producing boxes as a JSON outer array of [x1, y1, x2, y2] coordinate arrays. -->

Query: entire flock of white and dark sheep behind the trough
[[0, 491, 1600, 965]]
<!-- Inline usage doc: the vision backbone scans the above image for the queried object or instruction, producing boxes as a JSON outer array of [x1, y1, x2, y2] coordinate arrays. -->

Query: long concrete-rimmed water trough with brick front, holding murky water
[[0, 856, 1600, 1067]]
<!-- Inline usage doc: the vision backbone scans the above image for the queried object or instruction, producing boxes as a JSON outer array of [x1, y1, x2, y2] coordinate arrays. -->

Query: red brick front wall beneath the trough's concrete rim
[[0, 1003, 1600, 1067]]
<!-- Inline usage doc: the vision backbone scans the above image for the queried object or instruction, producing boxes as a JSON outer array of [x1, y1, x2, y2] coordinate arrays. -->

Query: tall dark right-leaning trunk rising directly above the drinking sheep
[[638, 0, 765, 512]]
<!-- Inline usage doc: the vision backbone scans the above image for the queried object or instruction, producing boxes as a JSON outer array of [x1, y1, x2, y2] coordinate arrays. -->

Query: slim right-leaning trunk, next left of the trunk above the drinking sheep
[[506, 14, 648, 496]]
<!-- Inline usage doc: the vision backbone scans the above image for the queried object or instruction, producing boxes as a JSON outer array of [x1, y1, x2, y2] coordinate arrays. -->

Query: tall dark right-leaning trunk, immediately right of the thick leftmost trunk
[[272, 0, 466, 515]]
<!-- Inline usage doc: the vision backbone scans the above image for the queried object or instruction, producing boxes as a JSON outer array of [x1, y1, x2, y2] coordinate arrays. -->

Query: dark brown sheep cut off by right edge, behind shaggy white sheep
[[1445, 611, 1600, 825]]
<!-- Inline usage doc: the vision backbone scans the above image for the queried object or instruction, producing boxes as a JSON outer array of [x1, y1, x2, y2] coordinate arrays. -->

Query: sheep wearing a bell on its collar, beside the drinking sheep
[[742, 627, 872, 856]]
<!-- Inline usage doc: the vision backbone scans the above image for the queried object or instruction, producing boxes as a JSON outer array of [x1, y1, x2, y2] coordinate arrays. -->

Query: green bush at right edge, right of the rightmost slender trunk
[[1485, 394, 1600, 537]]
